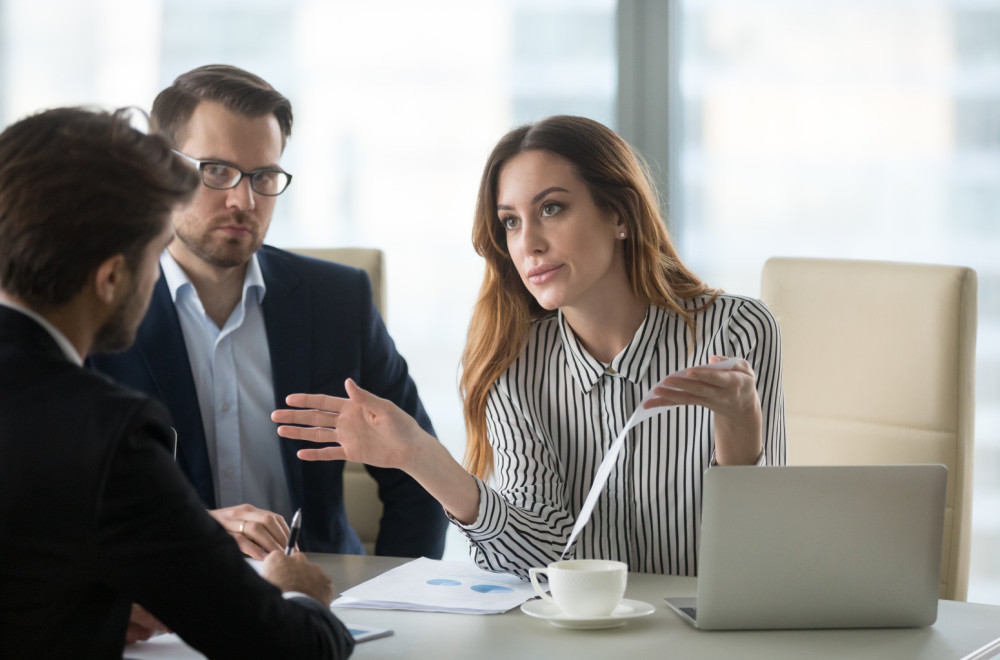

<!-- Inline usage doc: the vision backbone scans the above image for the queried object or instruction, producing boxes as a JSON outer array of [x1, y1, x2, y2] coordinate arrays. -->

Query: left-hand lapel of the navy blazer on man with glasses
[[135, 273, 215, 509]]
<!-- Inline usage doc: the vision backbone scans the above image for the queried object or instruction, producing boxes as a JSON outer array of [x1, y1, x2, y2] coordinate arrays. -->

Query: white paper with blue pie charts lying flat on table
[[333, 557, 535, 614]]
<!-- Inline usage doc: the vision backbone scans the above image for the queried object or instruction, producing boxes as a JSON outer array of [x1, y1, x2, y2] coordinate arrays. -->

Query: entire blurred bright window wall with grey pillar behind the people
[[0, 0, 1000, 604]]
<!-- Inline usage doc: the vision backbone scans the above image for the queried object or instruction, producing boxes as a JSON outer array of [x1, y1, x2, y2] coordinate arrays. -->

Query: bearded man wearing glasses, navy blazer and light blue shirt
[[92, 65, 447, 558]]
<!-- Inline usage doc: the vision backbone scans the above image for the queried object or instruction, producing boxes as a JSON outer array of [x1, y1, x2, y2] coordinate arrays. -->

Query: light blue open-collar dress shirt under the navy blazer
[[160, 251, 292, 520]]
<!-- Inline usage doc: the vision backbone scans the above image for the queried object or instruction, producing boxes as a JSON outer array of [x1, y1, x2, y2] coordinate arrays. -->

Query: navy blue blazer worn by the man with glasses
[[89, 245, 448, 558]]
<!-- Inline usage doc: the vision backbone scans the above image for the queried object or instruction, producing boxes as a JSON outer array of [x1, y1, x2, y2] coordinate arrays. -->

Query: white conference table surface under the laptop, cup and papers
[[316, 553, 1000, 660]]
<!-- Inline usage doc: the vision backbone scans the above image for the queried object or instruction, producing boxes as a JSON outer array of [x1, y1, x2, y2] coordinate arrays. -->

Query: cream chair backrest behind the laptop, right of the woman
[[761, 258, 976, 600]]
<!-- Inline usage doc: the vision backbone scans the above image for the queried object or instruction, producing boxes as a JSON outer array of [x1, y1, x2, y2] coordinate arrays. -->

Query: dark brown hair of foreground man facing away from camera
[[0, 108, 198, 309]]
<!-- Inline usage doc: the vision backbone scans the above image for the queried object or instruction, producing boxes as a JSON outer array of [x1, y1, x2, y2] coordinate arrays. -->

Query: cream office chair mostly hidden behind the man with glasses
[[290, 248, 385, 555]]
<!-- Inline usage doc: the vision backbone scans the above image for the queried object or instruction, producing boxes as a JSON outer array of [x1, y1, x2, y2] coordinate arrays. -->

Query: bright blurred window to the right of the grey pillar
[[671, 0, 1000, 604]]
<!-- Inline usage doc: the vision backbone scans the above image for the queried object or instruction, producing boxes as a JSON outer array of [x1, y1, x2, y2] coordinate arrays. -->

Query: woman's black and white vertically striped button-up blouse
[[459, 294, 785, 576]]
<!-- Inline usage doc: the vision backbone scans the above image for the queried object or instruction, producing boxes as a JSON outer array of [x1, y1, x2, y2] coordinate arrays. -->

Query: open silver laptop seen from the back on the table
[[666, 465, 947, 630]]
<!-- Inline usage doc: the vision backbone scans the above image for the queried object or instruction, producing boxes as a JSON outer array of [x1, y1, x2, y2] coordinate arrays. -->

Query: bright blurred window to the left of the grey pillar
[[0, 0, 617, 558]]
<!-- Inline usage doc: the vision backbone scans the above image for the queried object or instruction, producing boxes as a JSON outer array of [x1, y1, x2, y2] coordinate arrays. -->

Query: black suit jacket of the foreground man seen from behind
[[0, 306, 353, 659]]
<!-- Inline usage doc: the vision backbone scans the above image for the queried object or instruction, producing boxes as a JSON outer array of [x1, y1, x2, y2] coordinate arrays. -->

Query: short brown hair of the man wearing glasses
[[150, 64, 292, 148]]
